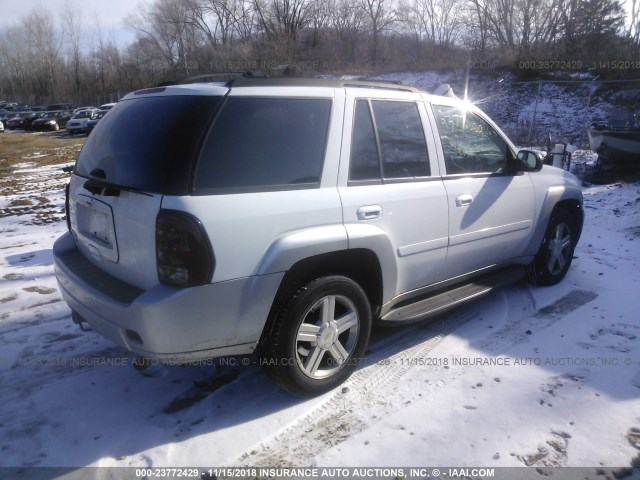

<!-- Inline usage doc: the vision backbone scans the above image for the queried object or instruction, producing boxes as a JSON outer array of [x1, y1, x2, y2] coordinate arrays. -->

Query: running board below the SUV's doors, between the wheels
[[380, 266, 525, 323]]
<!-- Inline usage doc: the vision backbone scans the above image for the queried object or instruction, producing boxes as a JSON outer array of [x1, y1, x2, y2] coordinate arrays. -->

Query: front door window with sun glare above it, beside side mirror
[[433, 105, 509, 175]]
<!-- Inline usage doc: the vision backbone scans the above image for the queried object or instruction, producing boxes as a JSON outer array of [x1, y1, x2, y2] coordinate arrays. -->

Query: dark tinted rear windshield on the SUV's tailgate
[[75, 95, 221, 195]]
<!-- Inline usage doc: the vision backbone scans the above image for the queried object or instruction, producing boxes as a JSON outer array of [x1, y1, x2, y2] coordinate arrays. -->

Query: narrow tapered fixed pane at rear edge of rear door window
[[349, 100, 381, 180]]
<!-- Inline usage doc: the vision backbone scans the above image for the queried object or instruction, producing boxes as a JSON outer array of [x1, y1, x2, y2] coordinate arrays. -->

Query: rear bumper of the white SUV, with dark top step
[[53, 233, 284, 362]]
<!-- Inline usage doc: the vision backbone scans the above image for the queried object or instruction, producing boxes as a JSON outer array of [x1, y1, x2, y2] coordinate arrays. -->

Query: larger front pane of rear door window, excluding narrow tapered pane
[[371, 100, 430, 178]]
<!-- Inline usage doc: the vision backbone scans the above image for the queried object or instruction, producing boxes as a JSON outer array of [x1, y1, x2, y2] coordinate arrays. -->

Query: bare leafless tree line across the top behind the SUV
[[0, 0, 640, 104]]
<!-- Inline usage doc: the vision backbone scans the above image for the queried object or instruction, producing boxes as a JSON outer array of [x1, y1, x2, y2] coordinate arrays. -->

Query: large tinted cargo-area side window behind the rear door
[[194, 97, 331, 194]]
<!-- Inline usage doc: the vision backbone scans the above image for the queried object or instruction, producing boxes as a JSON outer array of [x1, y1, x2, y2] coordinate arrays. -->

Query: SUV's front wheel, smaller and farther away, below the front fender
[[530, 208, 578, 286]]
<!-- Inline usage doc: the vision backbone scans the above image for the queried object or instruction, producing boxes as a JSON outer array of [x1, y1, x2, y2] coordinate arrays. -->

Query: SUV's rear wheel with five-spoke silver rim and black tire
[[260, 276, 371, 397]]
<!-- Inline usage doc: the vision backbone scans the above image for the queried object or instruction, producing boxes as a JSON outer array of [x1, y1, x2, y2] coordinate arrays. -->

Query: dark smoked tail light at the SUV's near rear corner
[[156, 210, 215, 287]]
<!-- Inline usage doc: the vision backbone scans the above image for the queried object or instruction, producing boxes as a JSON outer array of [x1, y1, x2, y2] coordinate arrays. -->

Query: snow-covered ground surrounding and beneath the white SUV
[[0, 84, 640, 478]]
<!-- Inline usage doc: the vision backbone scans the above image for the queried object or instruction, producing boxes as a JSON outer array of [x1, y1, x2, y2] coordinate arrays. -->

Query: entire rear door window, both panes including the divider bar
[[349, 100, 430, 181]]
